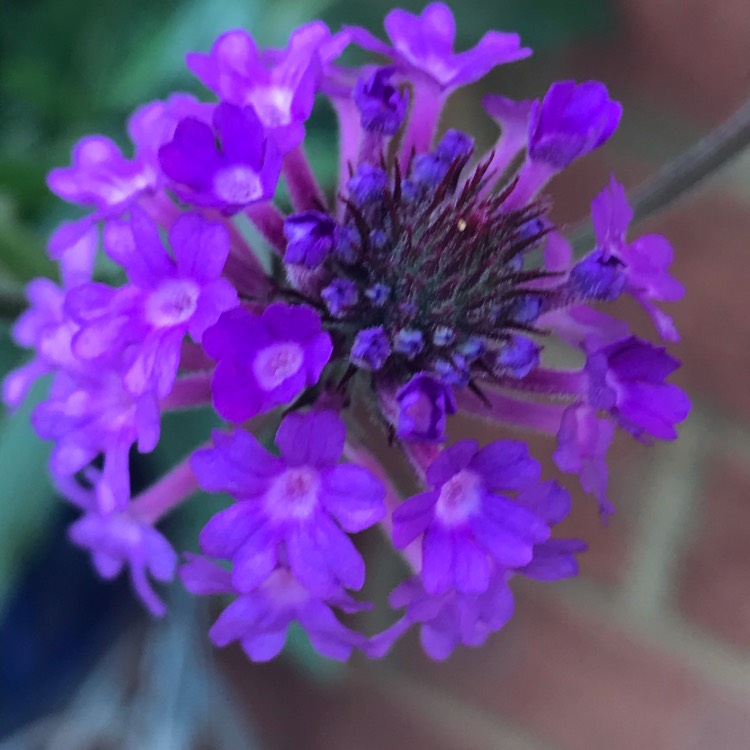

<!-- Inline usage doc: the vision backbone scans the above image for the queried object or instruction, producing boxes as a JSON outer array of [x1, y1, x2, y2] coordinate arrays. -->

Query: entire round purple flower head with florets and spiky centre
[[4, 3, 689, 660]]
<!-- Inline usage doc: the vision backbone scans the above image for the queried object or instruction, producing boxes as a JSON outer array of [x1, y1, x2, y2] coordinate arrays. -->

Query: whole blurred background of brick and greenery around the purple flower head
[[0, 0, 750, 750]]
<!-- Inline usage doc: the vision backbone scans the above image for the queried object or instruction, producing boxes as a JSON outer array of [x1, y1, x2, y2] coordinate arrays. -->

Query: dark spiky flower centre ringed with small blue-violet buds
[[284, 136, 549, 383]]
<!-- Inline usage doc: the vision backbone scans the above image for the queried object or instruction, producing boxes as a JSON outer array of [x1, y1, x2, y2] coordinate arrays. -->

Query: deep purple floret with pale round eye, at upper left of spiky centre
[[159, 102, 281, 213]]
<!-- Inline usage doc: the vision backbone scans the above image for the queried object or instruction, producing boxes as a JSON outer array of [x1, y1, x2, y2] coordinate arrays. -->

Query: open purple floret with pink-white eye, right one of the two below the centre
[[393, 440, 549, 594]]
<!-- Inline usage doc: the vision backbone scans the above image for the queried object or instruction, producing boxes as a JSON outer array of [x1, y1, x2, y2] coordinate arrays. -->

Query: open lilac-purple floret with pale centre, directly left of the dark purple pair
[[66, 209, 237, 398]]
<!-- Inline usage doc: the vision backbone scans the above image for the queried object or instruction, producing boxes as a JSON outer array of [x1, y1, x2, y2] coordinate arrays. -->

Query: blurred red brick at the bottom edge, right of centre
[[400, 597, 704, 750]]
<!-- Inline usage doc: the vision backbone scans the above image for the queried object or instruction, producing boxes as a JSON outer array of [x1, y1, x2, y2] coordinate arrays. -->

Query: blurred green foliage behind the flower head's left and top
[[0, 0, 611, 616]]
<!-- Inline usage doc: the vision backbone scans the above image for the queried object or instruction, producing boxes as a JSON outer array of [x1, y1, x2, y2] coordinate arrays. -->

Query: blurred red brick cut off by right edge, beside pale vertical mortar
[[679, 456, 750, 648]]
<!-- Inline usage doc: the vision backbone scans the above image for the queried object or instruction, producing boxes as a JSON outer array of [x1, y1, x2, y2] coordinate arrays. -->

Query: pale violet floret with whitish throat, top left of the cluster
[[187, 21, 347, 153]]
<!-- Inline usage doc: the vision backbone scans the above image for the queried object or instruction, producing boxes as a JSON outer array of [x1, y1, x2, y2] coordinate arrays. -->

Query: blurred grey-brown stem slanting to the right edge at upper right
[[571, 94, 750, 249]]
